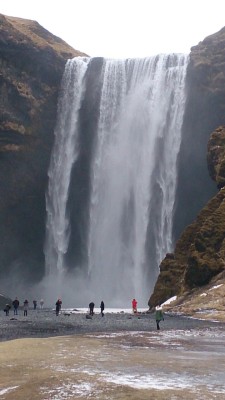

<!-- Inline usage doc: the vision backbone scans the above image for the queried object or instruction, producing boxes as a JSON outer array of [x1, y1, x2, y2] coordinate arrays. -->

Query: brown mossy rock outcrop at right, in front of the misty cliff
[[149, 126, 225, 307]]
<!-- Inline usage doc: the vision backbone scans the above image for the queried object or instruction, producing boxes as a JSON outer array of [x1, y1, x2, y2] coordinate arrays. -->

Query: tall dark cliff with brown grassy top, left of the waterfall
[[0, 15, 85, 280]]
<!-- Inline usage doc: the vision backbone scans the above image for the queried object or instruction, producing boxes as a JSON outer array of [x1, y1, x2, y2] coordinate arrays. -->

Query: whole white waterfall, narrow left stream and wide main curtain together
[[46, 54, 188, 306]]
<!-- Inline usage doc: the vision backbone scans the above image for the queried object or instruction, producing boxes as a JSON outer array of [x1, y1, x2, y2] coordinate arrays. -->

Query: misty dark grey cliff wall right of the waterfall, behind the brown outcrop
[[174, 28, 225, 240]]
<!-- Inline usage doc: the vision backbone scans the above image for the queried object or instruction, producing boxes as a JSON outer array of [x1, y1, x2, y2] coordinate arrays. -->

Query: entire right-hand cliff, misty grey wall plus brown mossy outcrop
[[149, 28, 225, 308]]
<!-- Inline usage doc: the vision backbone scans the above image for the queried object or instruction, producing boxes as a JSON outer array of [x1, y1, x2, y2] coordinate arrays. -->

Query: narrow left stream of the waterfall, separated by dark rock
[[45, 57, 88, 274]]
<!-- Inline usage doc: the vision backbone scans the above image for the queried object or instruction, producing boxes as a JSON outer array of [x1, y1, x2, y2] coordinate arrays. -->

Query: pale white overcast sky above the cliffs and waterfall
[[0, 0, 225, 58]]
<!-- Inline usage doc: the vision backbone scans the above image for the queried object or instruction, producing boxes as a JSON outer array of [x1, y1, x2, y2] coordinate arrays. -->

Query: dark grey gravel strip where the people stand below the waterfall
[[0, 309, 225, 341]]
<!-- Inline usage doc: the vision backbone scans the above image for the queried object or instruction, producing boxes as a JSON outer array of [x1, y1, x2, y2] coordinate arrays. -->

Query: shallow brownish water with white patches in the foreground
[[0, 326, 225, 400]]
